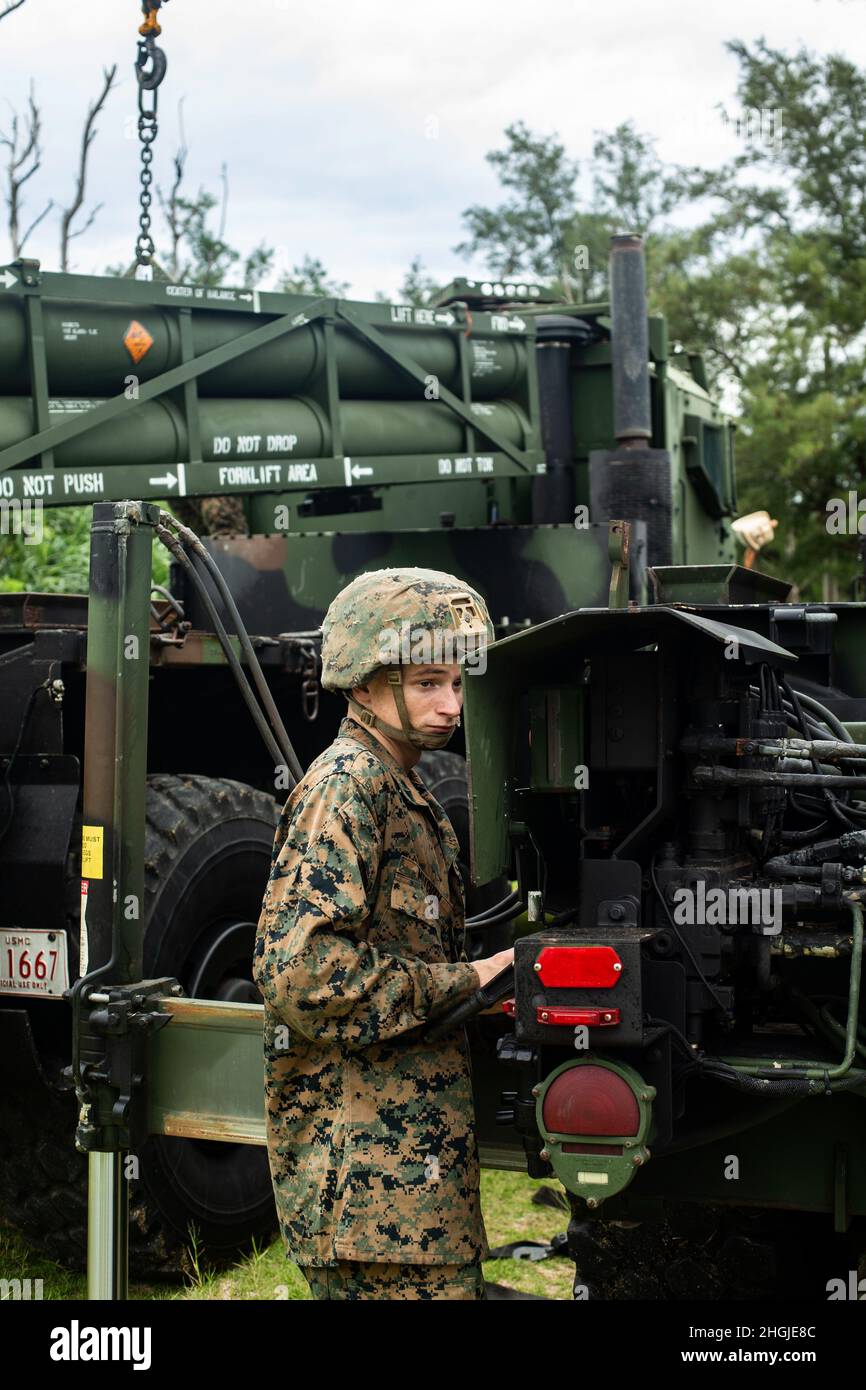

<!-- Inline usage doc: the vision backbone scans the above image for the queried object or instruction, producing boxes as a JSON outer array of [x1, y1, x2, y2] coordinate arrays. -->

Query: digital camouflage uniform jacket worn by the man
[[253, 717, 489, 1265]]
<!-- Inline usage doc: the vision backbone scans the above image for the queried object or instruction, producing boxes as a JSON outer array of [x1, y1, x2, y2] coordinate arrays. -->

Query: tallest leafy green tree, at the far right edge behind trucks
[[692, 39, 866, 598]]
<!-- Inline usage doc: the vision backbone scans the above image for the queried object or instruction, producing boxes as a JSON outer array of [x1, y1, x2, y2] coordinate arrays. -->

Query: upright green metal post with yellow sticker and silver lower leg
[[74, 502, 158, 1298]]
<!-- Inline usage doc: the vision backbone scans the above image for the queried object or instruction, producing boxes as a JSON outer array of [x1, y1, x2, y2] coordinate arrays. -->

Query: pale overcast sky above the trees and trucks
[[0, 0, 866, 297]]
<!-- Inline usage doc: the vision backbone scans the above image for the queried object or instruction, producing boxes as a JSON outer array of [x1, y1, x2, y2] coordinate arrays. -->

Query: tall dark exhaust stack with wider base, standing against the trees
[[589, 235, 673, 564]]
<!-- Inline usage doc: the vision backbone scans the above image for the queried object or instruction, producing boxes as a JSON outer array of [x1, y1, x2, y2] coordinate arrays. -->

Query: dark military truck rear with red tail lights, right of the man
[[453, 566, 866, 1300]]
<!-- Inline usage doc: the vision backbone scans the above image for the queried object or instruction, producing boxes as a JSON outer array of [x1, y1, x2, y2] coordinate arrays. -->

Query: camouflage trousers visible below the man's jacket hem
[[299, 1259, 487, 1302]]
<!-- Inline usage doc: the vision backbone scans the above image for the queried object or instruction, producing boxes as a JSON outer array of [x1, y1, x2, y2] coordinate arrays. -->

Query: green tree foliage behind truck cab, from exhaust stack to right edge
[[457, 52, 866, 599]]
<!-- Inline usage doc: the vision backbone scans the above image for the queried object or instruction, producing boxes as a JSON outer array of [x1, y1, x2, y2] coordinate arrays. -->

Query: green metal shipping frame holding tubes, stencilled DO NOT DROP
[[0, 260, 545, 506]]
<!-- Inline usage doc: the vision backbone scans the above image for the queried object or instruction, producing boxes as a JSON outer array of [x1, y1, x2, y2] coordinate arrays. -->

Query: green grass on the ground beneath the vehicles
[[0, 1169, 574, 1301]]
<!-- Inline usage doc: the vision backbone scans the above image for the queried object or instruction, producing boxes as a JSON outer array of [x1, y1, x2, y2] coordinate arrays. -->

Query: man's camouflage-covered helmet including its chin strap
[[321, 569, 493, 748]]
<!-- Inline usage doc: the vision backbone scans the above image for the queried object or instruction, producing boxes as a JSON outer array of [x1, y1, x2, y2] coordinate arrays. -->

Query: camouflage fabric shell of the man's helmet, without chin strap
[[321, 569, 493, 691]]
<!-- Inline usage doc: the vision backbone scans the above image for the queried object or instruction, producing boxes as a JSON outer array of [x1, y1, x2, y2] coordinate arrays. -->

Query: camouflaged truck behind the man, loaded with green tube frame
[[0, 230, 735, 1275]]
